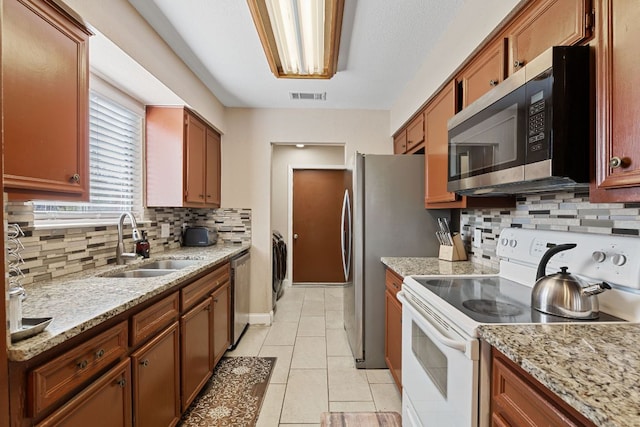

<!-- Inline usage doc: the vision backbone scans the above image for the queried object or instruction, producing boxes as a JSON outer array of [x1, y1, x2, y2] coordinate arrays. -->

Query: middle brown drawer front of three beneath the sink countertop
[[129, 292, 179, 347]]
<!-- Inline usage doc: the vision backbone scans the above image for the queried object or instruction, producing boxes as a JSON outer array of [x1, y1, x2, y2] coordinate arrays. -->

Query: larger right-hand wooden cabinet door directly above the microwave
[[508, 0, 591, 74]]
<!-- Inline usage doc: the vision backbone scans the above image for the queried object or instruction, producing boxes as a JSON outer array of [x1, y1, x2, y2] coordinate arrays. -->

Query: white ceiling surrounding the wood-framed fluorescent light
[[129, 0, 468, 110]]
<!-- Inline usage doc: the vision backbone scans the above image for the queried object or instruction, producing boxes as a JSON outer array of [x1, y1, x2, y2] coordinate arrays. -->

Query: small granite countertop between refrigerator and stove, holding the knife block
[[381, 257, 498, 277]]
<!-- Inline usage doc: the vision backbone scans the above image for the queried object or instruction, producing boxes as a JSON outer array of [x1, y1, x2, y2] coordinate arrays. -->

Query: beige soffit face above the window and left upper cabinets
[[64, 0, 226, 133]]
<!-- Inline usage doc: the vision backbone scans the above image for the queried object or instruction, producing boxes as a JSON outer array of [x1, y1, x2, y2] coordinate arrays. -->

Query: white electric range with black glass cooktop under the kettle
[[398, 228, 640, 427]]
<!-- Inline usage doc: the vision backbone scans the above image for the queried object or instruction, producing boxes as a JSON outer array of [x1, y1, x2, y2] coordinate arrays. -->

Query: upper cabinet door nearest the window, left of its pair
[[185, 113, 206, 204]]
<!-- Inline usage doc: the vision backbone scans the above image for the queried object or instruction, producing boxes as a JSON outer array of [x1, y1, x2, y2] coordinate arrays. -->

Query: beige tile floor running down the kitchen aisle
[[227, 287, 402, 427]]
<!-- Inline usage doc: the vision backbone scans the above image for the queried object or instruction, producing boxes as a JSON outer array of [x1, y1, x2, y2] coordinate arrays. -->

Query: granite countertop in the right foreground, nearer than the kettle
[[479, 323, 640, 427]]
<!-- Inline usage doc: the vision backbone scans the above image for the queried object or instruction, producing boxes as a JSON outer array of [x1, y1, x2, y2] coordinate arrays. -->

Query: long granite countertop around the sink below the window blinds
[[7, 243, 251, 361]]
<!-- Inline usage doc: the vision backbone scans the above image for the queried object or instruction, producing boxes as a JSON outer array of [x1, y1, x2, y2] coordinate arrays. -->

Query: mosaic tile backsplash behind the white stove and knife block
[[460, 192, 640, 268]]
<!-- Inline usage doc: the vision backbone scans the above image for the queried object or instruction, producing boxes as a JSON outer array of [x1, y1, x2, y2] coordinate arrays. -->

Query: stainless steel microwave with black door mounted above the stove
[[447, 46, 593, 195]]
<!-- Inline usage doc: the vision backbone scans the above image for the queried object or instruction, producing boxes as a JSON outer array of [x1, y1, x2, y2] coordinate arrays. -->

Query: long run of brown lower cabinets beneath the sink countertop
[[9, 262, 231, 427]]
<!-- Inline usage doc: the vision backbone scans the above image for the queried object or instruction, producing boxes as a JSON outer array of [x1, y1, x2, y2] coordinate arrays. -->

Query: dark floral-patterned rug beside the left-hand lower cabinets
[[180, 357, 276, 427]]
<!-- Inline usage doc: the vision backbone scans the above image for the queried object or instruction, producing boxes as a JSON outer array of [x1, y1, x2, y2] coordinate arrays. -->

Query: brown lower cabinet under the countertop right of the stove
[[491, 348, 595, 427]]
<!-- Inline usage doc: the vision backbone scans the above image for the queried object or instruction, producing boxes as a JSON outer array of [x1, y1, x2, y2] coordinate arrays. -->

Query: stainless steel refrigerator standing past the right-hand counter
[[341, 153, 449, 369]]
